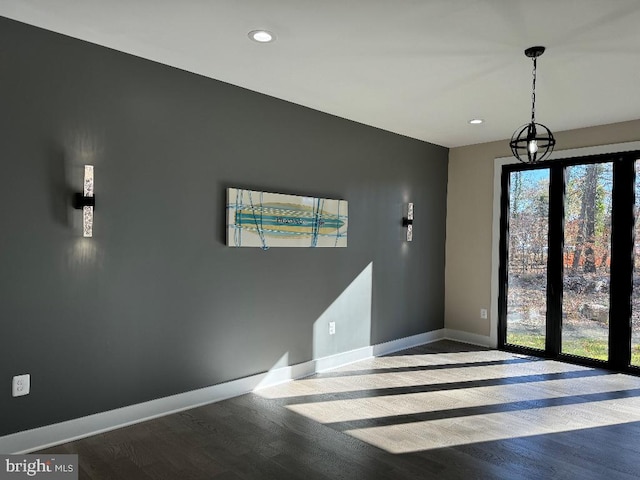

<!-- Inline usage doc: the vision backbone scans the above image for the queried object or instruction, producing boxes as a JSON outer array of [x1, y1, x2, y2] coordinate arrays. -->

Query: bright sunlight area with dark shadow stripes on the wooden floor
[[256, 344, 640, 454]]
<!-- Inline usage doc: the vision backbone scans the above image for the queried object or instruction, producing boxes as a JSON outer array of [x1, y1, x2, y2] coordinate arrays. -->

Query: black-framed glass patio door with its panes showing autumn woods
[[499, 152, 640, 369]]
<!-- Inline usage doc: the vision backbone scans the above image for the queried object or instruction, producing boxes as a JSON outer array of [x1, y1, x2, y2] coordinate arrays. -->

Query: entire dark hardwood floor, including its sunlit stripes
[[41, 341, 640, 480]]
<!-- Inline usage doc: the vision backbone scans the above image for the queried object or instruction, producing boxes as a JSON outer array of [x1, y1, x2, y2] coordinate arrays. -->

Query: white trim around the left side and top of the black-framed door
[[489, 142, 640, 347]]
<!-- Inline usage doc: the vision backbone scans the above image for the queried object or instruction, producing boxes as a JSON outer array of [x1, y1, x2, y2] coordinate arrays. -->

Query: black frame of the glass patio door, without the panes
[[498, 150, 640, 375]]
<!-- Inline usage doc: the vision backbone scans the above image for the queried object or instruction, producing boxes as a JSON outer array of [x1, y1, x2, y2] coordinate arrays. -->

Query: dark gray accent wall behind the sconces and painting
[[0, 18, 448, 436]]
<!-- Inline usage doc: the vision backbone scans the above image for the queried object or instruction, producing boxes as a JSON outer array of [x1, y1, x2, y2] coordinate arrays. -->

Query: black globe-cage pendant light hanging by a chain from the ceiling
[[509, 47, 556, 163]]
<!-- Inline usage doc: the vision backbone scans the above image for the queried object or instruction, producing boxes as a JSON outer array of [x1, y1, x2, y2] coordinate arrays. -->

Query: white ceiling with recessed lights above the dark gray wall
[[0, 0, 640, 147]]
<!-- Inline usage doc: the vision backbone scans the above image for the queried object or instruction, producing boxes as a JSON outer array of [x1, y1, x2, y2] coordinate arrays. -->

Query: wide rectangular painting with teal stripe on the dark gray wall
[[227, 188, 349, 250]]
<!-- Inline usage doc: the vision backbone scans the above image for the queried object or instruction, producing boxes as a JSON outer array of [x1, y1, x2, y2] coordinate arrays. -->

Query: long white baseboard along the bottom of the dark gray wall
[[0, 329, 450, 454]]
